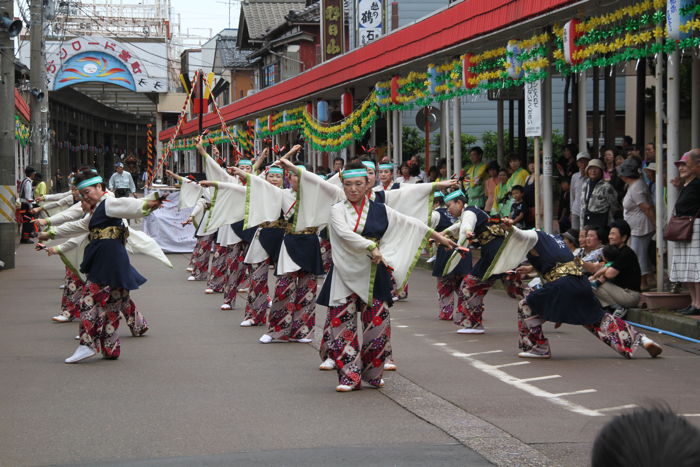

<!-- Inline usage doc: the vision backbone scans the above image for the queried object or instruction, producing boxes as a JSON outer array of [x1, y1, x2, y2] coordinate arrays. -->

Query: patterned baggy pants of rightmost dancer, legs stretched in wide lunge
[[518, 298, 643, 358]]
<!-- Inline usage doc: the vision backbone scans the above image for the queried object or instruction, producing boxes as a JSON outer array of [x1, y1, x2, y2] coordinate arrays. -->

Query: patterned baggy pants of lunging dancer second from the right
[[454, 274, 523, 328]]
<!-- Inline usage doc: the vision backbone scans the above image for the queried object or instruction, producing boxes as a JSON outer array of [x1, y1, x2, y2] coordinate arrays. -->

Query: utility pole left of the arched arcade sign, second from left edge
[[29, 0, 51, 179]]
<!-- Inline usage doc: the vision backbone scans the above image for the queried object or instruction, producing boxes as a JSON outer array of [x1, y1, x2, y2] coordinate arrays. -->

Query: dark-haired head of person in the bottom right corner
[[591, 408, 700, 467]]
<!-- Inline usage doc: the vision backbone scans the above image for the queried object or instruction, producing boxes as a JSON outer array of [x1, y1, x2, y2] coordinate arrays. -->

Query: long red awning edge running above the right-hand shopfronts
[[163, 0, 574, 140]]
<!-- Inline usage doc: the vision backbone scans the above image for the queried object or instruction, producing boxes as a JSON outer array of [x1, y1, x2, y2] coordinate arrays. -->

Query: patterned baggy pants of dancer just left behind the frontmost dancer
[[267, 271, 318, 340]]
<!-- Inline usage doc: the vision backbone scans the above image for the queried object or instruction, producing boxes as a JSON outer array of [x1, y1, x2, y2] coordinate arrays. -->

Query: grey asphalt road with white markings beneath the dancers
[[0, 245, 700, 466]]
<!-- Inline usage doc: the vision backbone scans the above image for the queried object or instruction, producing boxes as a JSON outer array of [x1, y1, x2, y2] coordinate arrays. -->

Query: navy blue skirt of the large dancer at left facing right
[[80, 239, 146, 290]]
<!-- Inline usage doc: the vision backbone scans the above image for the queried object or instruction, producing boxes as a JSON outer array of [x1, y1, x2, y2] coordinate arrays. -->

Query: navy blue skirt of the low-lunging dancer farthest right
[[525, 276, 605, 324]]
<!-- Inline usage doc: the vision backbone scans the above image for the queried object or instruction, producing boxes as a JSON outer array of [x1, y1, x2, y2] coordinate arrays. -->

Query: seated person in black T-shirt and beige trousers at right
[[591, 220, 642, 318]]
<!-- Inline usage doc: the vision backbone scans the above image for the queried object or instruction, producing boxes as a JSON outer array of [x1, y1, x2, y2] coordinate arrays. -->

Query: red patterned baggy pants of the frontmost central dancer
[[326, 294, 391, 389]]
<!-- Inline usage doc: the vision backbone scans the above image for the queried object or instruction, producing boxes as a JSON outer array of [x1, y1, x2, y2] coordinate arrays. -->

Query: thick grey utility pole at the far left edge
[[0, 0, 17, 269]]
